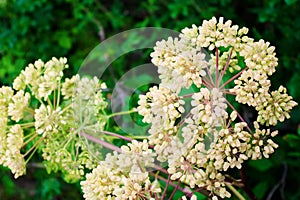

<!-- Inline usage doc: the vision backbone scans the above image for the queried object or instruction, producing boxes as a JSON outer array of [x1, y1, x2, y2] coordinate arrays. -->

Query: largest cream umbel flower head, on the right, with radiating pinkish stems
[[138, 18, 297, 199]]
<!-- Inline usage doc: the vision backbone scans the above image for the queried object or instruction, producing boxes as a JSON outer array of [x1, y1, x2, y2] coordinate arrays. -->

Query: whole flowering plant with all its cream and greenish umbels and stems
[[0, 18, 297, 200]]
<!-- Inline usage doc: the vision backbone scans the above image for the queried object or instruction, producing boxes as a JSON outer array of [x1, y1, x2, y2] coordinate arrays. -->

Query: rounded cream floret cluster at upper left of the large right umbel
[[151, 37, 207, 93]]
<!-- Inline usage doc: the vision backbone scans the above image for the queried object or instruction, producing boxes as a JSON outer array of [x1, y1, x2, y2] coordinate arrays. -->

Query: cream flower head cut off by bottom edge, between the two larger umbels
[[81, 140, 161, 200]]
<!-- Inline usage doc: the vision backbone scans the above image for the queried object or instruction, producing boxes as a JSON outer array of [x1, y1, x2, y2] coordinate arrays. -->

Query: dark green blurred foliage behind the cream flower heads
[[0, 0, 300, 200]]
